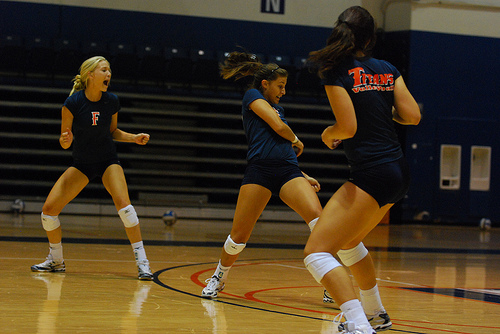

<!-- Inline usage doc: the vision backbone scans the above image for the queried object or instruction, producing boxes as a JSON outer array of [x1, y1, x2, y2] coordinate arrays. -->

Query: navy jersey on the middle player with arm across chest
[[242, 89, 298, 166]]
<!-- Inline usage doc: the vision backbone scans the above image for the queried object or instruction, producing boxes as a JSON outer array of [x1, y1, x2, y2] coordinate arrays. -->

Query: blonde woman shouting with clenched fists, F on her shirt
[[31, 56, 153, 280]]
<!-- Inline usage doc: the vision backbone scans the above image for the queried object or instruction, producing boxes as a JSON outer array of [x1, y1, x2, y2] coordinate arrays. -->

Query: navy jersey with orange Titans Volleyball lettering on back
[[322, 57, 403, 170]]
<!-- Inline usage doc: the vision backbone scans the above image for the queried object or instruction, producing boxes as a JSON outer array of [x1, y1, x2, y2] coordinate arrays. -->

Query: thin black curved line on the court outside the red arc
[[153, 259, 426, 334]]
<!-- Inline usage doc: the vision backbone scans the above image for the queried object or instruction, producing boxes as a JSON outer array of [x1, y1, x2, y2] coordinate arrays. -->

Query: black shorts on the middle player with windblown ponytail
[[241, 160, 304, 195]]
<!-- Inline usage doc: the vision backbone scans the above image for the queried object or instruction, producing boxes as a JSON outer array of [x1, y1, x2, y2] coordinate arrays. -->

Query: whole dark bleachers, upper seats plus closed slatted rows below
[[0, 37, 347, 209]]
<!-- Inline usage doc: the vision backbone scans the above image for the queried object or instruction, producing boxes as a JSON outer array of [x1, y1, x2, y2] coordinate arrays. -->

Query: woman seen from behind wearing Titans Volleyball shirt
[[304, 6, 421, 334]]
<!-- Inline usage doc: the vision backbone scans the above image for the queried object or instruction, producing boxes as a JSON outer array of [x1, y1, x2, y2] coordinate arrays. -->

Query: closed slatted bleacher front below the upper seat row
[[0, 86, 346, 204]]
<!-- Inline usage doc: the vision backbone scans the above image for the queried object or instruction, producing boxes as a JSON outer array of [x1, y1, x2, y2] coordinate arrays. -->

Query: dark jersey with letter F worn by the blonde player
[[64, 90, 120, 163]]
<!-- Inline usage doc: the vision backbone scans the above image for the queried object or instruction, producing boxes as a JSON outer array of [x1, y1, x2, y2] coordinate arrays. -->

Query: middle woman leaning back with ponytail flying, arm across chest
[[201, 52, 321, 298]]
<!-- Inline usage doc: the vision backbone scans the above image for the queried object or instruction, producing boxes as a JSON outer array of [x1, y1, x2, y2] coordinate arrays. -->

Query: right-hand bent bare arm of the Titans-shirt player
[[393, 77, 422, 125]]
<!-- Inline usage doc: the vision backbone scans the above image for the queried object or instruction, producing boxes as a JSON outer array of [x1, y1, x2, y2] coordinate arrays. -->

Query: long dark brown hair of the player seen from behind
[[307, 6, 376, 78]]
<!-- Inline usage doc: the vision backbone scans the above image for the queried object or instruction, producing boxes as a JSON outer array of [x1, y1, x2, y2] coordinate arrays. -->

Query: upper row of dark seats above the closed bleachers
[[0, 35, 324, 99]]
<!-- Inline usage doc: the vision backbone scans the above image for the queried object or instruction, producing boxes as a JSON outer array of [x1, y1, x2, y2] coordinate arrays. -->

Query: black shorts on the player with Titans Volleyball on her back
[[349, 158, 410, 207]]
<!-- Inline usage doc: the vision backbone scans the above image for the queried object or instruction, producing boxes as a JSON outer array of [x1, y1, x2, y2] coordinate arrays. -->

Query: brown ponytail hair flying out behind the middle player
[[219, 51, 288, 90]]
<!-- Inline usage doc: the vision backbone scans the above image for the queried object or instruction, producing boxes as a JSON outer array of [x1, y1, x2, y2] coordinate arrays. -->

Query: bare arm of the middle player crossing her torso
[[249, 99, 304, 156]]
